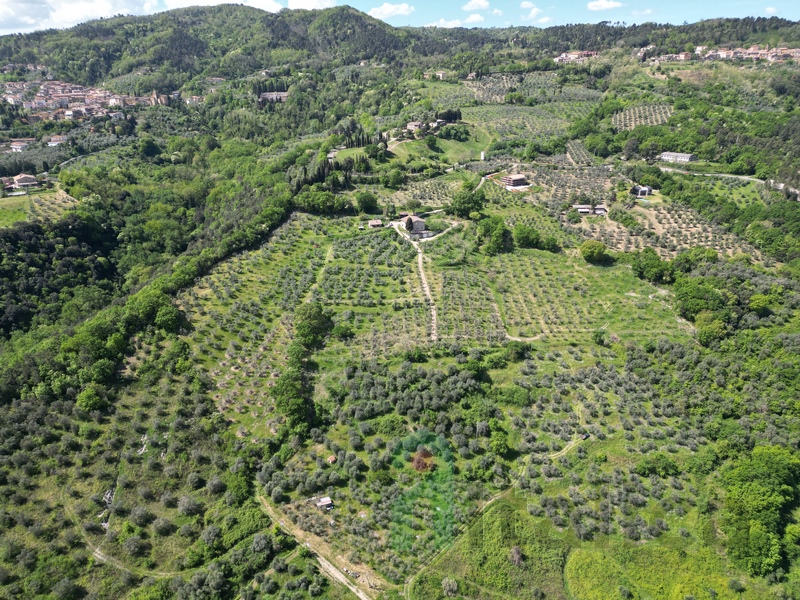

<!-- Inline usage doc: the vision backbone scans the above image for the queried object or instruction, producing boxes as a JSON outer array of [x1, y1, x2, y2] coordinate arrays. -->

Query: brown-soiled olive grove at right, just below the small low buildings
[[570, 204, 763, 261]]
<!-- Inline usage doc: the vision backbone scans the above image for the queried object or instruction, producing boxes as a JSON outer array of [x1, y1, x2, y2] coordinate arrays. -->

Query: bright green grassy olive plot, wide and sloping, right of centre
[[488, 250, 688, 343]]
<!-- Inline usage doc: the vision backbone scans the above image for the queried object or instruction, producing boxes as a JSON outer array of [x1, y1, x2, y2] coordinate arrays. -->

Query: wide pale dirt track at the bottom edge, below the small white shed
[[257, 496, 382, 600]]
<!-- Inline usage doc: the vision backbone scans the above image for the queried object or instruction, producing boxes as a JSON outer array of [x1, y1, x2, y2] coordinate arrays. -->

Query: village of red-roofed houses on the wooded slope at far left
[[2, 80, 192, 122]]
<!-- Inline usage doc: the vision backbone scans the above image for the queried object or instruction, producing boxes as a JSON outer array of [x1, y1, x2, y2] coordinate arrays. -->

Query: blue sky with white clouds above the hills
[[0, 0, 800, 35]]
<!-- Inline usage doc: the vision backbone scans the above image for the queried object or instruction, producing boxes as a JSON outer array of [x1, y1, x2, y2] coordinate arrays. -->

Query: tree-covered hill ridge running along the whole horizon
[[0, 5, 800, 91]]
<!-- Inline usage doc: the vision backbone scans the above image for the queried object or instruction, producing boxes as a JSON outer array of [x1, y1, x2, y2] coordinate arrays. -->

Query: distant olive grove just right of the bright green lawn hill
[[461, 105, 569, 145]]
